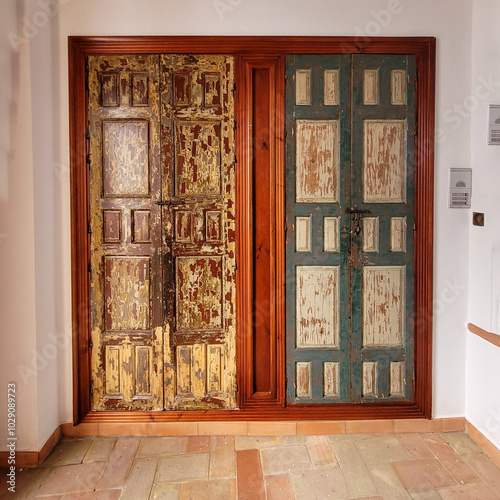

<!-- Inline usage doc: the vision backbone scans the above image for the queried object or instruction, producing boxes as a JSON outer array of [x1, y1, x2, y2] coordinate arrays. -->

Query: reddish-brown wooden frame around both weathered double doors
[[68, 36, 436, 423]]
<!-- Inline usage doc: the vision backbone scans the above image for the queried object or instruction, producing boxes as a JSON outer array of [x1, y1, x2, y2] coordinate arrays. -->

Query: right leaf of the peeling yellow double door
[[161, 55, 236, 409]]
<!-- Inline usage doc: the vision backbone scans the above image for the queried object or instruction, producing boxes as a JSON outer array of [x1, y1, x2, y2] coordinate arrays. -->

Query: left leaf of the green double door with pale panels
[[286, 55, 351, 403]]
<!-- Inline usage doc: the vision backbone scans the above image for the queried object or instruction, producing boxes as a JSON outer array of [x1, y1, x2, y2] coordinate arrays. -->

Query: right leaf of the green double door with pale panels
[[351, 54, 416, 402]]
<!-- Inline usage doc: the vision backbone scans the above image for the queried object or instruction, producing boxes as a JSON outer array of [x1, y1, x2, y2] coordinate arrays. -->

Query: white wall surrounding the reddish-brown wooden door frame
[[0, 0, 472, 449]]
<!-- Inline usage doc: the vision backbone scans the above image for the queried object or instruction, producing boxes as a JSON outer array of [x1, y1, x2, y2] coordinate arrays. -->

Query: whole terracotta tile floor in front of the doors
[[0, 432, 500, 500]]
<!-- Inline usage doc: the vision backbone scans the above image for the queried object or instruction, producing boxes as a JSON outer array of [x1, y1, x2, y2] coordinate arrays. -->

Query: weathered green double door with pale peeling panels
[[286, 55, 415, 403]]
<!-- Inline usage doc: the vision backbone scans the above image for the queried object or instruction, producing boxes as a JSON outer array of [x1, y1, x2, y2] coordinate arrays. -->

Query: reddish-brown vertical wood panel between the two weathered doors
[[236, 56, 285, 408]]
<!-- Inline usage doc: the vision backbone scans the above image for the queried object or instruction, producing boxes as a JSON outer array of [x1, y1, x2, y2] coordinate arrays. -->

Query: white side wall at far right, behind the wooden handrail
[[466, 0, 500, 447]]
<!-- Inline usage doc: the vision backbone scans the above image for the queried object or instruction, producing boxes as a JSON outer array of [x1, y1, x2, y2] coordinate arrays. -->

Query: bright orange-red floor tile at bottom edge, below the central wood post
[[236, 450, 266, 500]]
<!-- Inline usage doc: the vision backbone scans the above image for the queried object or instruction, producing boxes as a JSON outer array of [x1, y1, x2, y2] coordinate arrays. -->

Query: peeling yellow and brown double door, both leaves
[[88, 55, 235, 410]]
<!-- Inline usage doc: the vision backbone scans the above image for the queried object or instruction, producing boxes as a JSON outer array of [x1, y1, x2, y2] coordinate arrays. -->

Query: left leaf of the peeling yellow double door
[[89, 56, 163, 410]]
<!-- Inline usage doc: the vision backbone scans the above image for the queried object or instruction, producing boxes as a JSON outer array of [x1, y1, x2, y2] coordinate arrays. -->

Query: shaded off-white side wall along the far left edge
[[0, 0, 39, 450]]
